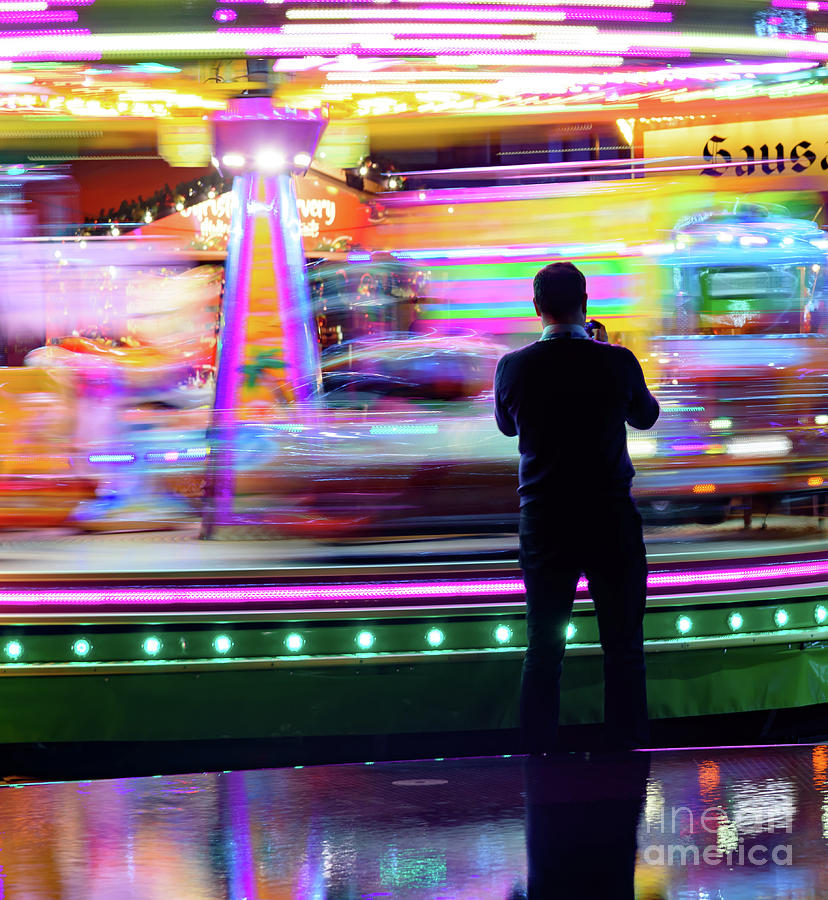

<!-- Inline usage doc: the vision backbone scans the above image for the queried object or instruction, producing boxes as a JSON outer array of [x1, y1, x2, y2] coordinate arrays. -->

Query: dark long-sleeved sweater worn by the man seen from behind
[[495, 335, 659, 506]]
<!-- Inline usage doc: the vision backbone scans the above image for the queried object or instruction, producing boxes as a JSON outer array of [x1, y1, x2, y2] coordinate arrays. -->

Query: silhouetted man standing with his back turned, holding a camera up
[[495, 262, 659, 753]]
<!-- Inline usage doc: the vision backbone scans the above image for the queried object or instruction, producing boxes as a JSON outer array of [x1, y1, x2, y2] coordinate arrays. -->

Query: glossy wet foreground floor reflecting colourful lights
[[0, 745, 828, 900]]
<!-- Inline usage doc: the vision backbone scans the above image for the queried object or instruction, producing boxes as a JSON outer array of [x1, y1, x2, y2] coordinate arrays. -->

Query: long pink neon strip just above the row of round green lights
[[0, 559, 828, 607]]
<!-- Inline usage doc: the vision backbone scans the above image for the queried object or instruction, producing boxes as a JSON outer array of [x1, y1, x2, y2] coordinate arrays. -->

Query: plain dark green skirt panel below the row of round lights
[[0, 644, 828, 743]]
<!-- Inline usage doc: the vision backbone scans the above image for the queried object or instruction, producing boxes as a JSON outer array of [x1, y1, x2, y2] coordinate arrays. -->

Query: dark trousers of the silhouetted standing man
[[520, 490, 648, 753]]
